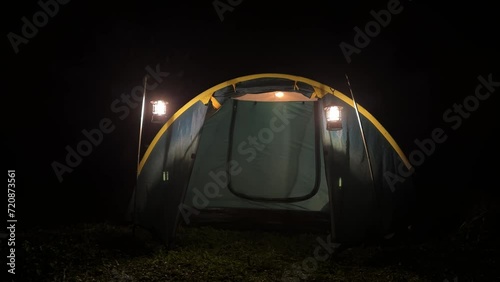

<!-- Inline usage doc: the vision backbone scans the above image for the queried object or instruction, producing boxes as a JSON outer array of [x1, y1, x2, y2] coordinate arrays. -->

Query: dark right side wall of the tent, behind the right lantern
[[322, 95, 412, 241]]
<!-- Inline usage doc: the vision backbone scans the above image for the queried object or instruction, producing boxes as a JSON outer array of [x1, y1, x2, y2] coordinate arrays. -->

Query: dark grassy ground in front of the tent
[[10, 217, 500, 282]]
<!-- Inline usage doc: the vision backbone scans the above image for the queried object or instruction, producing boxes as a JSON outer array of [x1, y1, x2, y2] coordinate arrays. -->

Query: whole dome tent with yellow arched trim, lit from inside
[[131, 74, 413, 244]]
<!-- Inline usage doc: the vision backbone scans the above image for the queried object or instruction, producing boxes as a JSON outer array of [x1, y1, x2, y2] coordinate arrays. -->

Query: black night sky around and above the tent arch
[[3, 0, 500, 232]]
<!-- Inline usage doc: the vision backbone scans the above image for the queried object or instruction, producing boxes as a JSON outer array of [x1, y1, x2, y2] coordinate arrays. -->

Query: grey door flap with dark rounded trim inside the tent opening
[[227, 100, 321, 202]]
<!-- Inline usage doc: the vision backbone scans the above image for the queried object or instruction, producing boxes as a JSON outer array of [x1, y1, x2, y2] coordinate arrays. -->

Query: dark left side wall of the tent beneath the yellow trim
[[136, 102, 207, 241]]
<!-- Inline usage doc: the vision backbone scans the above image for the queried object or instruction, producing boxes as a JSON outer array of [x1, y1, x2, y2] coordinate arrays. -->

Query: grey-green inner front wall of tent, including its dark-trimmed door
[[185, 100, 328, 211]]
